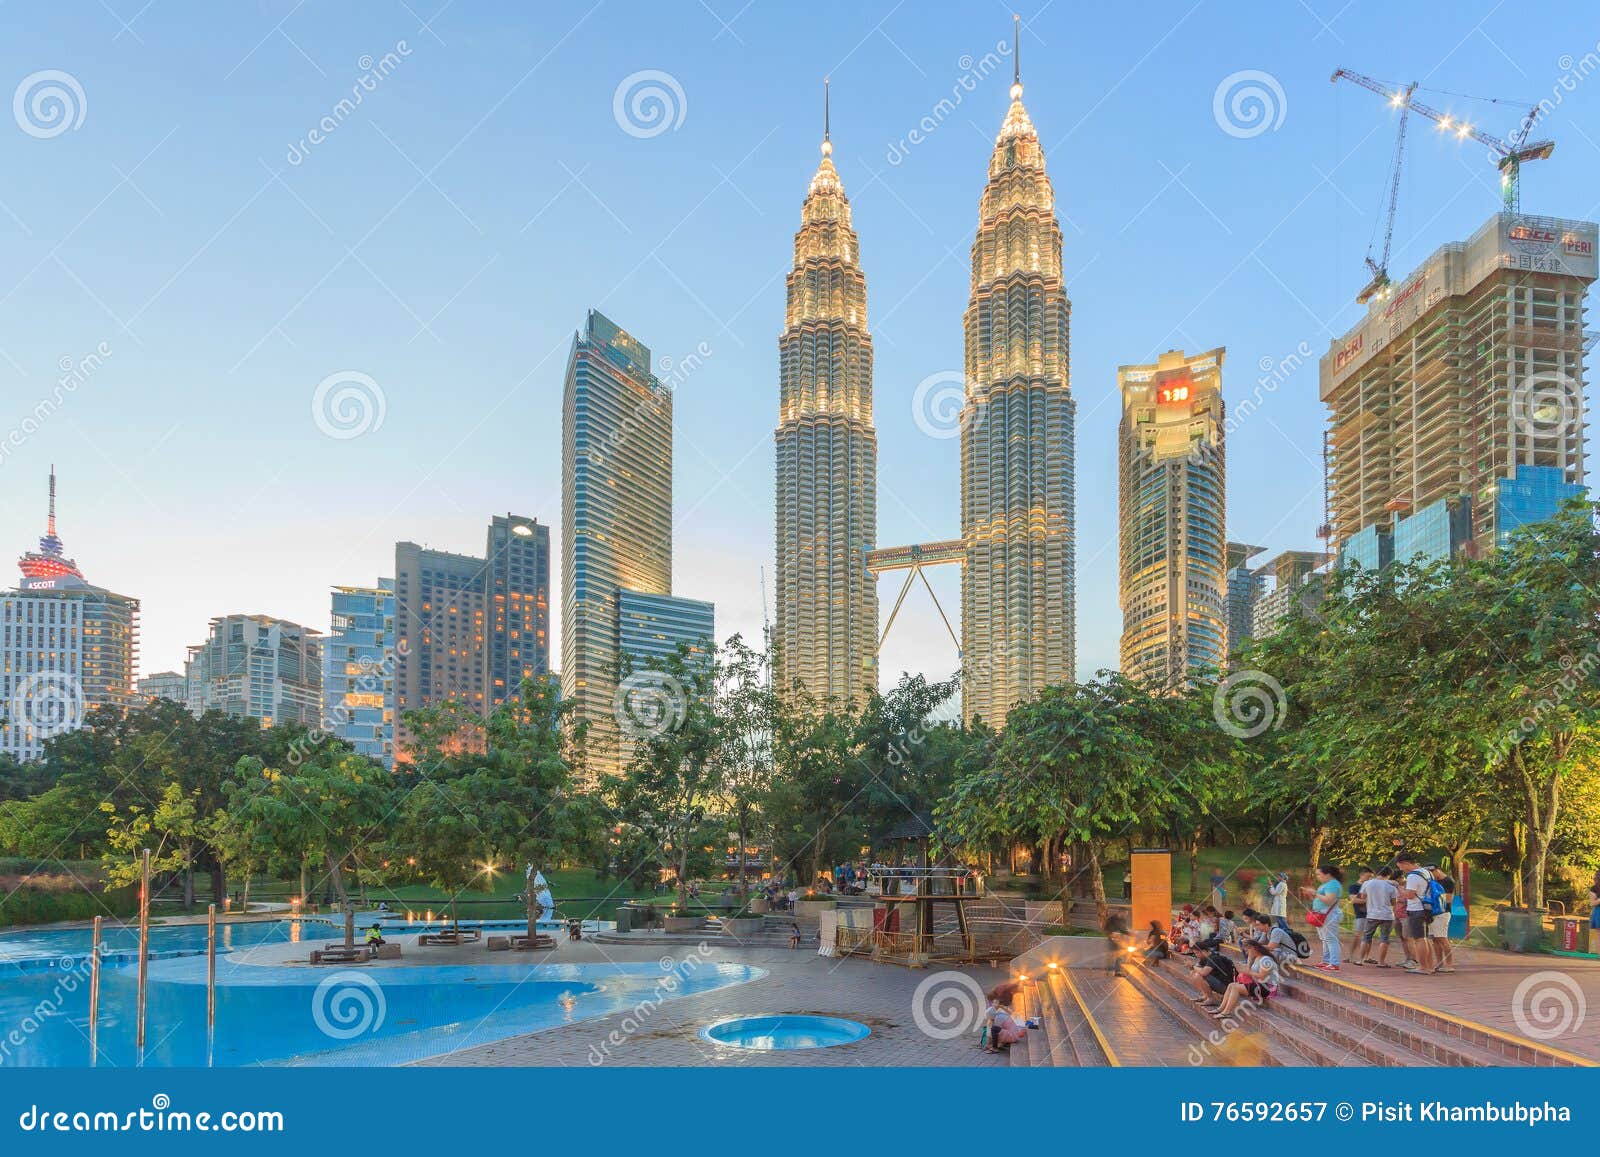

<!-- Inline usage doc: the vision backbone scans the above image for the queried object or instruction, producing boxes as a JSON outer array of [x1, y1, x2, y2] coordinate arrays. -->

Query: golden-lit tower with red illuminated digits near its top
[[1117, 349, 1227, 690]]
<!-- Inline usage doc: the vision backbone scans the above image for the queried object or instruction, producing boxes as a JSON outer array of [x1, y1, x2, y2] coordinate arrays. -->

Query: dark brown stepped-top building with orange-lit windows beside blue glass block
[[392, 514, 550, 762]]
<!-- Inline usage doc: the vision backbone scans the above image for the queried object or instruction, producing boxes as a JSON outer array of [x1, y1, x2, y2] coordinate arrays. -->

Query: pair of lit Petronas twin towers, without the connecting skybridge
[[773, 56, 1075, 725]]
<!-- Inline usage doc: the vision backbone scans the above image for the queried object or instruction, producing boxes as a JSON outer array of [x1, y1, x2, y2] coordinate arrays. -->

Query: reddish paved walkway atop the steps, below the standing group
[[1338, 944, 1600, 1061]]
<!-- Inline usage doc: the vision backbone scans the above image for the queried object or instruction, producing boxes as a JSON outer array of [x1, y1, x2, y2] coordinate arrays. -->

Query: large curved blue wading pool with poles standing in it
[[0, 922, 766, 1067]]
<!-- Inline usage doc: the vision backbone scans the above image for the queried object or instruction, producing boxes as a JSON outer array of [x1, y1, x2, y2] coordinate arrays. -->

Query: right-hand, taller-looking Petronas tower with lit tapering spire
[[962, 63, 1077, 727]]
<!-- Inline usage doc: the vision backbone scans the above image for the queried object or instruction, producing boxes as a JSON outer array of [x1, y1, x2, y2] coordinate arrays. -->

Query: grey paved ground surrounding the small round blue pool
[[418, 936, 1006, 1067]]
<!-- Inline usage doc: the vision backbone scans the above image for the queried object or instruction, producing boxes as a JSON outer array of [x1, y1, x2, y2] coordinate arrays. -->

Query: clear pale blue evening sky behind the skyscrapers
[[0, 0, 1600, 679]]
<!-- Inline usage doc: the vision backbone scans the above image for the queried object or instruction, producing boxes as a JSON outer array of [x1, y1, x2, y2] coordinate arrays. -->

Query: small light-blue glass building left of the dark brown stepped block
[[322, 579, 395, 767]]
